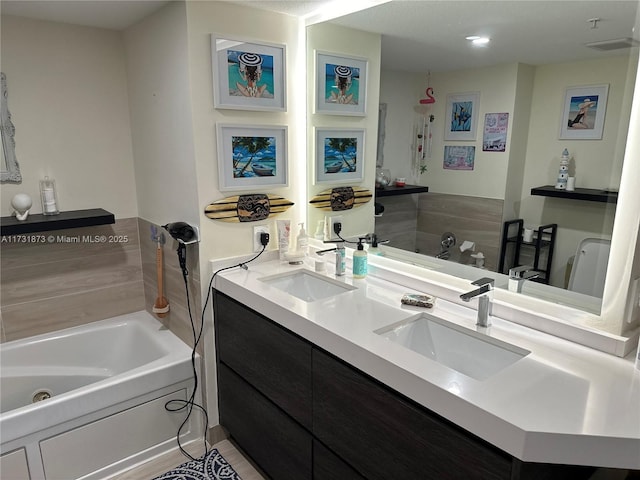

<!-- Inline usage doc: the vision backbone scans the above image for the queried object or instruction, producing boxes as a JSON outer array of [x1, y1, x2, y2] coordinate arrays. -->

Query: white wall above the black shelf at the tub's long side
[[0, 15, 138, 218]]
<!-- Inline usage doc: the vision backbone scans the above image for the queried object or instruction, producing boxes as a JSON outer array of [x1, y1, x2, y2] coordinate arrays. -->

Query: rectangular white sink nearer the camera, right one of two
[[375, 313, 531, 380]]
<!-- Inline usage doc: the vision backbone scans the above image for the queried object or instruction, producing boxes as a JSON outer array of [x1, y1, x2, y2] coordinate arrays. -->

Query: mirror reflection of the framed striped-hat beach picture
[[315, 52, 367, 116]]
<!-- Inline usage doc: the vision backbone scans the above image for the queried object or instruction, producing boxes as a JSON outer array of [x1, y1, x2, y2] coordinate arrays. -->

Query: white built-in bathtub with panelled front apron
[[0, 312, 203, 480]]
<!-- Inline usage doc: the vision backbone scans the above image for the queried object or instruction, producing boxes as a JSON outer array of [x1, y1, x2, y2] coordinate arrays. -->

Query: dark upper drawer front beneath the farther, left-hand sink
[[215, 293, 311, 430]]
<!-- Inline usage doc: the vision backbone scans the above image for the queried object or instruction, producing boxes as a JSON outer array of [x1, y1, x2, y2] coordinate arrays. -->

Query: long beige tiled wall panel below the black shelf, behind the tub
[[0, 218, 144, 342]]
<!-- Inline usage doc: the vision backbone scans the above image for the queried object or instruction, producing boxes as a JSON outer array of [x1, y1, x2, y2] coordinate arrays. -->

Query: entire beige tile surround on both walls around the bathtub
[[0, 218, 202, 353]]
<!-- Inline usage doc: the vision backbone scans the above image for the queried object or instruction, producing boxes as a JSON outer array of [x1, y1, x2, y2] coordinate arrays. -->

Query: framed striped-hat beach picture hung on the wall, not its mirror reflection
[[211, 35, 287, 111]]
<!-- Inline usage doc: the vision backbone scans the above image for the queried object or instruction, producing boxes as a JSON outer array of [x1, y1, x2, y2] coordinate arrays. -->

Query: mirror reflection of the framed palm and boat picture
[[316, 128, 364, 183]]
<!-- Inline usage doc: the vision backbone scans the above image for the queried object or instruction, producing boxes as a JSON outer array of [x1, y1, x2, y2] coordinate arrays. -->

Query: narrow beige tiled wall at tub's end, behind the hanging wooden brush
[[138, 218, 203, 355]]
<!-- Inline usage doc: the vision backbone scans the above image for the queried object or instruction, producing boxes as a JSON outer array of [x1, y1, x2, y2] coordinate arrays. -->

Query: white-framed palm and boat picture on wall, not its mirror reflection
[[217, 124, 288, 192]]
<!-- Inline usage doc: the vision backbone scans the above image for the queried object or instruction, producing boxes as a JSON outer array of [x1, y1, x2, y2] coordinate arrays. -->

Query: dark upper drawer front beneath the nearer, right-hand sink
[[313, 349, 511, 480]]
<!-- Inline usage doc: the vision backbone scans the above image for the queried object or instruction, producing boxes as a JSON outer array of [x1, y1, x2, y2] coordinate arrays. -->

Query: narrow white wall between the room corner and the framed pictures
[[124, 2, 200, 228]]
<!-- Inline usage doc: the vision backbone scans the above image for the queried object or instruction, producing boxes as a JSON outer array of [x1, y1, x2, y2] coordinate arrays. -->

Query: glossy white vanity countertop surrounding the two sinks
[[215, 255, 640, 469]]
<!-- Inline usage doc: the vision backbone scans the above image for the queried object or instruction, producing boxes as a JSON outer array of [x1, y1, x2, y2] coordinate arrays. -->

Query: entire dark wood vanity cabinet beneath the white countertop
[[214, 291, 590, 480]]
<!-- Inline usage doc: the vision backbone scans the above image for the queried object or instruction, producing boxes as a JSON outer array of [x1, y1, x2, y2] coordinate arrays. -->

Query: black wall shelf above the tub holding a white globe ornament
[[0, 208, 116, 235]]
